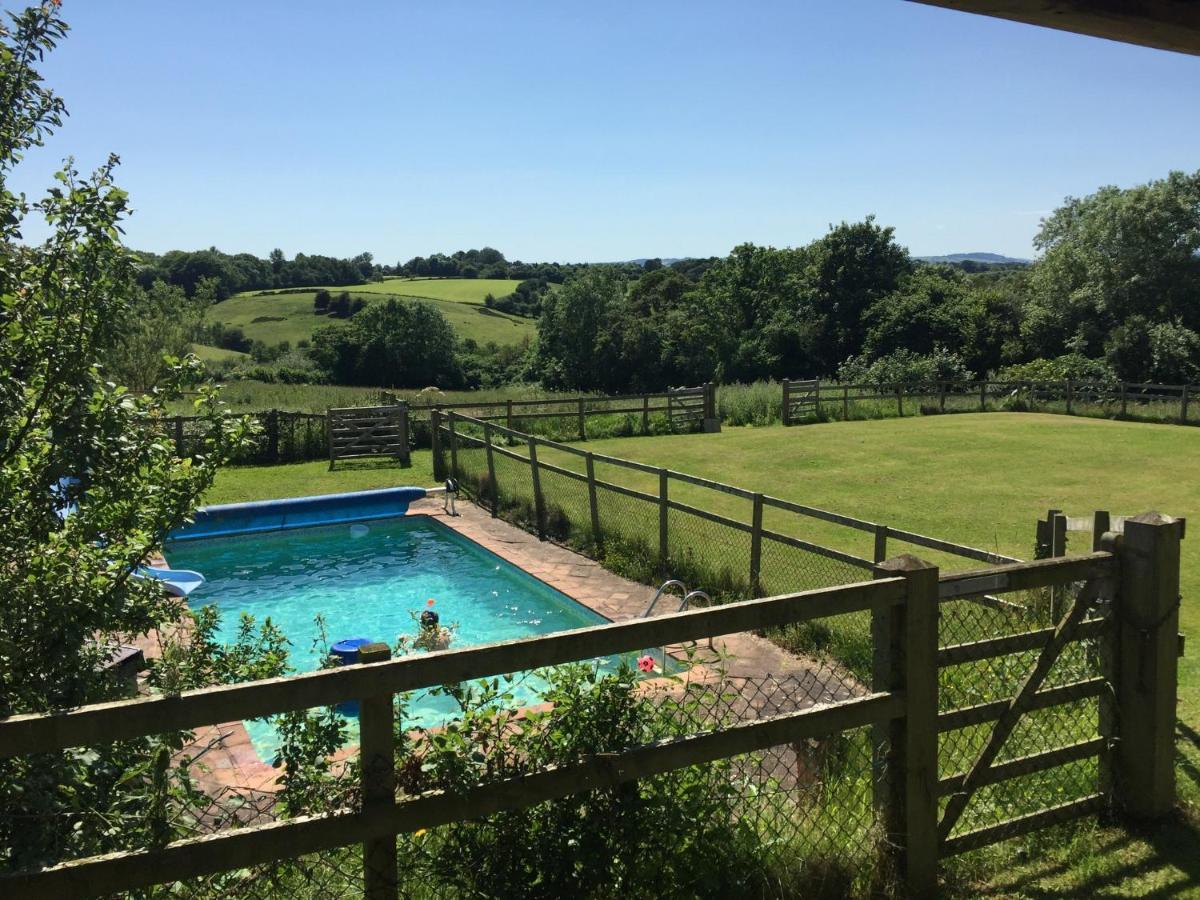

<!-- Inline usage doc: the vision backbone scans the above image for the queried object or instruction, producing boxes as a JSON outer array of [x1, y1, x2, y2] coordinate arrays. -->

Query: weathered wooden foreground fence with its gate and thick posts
[[0, 514, 1182, 898]]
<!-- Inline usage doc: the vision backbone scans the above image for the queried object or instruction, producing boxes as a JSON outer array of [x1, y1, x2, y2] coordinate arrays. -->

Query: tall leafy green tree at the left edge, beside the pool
[[0, 4, 255, 868]]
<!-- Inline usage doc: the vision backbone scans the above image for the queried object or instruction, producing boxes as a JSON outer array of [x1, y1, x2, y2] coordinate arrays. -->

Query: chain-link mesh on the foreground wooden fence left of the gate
[[112, 659, 893, 900]]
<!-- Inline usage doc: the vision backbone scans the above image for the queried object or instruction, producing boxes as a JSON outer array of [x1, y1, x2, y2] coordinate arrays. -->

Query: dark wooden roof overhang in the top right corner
[[911, 0, 1200, 55]]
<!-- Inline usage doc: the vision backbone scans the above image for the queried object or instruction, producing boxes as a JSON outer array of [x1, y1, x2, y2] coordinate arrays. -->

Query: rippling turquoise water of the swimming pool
[[167, 516, 662, 761]]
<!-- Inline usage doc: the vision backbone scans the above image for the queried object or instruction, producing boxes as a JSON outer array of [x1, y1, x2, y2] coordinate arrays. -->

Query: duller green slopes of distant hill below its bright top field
[[205, 282, 538, 347]]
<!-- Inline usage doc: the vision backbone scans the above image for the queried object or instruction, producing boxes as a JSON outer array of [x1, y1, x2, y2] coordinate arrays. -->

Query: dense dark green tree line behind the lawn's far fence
[[533, 172, 1200, 391]]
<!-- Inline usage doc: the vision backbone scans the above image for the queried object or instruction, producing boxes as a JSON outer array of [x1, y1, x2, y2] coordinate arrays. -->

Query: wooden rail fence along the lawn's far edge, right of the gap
[[782, 378, 1200, 425]]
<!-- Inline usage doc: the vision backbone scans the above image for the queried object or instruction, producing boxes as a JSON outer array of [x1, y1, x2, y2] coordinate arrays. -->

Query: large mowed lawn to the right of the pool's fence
[[561, 413, 1200, 725]]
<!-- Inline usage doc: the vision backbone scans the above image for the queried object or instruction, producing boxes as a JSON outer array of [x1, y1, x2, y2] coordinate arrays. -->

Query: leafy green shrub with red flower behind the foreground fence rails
[[419, 665, 764, 898]]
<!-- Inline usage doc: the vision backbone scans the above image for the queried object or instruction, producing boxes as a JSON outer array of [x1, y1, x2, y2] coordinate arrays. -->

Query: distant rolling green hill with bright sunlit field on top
[[205, 278, 536, 347]]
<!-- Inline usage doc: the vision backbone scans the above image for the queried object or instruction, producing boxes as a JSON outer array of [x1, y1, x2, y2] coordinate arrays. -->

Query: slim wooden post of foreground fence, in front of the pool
[[359, 643, 400, 900]]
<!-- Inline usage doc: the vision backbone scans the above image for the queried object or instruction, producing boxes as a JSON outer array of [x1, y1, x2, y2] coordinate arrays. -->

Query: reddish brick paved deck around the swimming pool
[[171, 497, 866, 796]]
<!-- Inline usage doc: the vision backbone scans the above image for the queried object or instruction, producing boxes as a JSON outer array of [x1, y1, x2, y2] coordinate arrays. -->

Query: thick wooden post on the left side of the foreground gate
[[871, 553, 938, 896]]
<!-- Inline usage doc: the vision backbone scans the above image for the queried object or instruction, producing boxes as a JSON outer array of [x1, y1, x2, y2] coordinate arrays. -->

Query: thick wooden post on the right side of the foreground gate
[[1114, 512, 1184, 820]]
